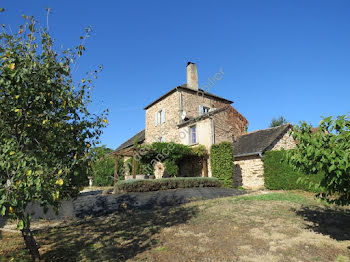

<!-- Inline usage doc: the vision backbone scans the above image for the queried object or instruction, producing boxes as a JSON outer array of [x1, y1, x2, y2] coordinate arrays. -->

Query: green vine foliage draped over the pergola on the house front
[[138, 142, 207, 177]]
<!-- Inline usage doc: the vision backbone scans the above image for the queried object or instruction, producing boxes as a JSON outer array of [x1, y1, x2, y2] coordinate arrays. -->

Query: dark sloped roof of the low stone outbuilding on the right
[[233, 124, 292, 157]]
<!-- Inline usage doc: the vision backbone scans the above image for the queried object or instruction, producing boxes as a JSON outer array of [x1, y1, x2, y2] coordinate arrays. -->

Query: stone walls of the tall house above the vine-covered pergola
[[145, 88, 248, 177]]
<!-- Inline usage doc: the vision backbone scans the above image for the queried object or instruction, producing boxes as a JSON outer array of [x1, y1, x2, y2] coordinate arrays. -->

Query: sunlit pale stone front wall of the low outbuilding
[[233, 156, 264, 189]]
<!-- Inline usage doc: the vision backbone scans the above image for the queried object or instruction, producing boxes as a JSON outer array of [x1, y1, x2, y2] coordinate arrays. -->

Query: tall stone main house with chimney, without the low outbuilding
[[115, 62, 248, 177]]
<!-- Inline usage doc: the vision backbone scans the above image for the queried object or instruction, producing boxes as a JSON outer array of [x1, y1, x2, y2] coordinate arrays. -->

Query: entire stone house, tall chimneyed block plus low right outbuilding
[[114, 62, 295, 188]]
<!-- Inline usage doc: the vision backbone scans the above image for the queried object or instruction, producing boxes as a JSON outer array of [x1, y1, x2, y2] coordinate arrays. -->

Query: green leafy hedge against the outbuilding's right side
[[264, 150, 323, 192]]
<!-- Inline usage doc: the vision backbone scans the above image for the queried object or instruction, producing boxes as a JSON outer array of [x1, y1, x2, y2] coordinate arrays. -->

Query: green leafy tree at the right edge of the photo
[[287, 115, 350, 205]]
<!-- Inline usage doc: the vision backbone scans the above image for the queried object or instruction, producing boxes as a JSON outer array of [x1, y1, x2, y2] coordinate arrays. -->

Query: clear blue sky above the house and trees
[[0, 0, 350, 148]]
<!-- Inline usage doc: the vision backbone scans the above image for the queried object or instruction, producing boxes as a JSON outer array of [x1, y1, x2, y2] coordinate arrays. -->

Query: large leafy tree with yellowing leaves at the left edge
[[0, 16, 108, 260]]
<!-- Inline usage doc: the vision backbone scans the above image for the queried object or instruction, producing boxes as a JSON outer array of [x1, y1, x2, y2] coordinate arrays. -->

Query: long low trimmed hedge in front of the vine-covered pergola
[[116, 177, 221, 193]]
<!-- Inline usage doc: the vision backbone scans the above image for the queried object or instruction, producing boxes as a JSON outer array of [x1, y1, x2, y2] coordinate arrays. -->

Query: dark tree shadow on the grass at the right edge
[[294, 207, 350, 240]]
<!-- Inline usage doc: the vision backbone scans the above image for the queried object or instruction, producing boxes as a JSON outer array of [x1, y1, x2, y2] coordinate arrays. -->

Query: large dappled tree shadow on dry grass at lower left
[[36, 206, 198, 261]]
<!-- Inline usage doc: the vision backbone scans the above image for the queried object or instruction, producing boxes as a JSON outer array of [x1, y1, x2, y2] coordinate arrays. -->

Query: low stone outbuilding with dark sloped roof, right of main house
[[233, 124, 296, 188]]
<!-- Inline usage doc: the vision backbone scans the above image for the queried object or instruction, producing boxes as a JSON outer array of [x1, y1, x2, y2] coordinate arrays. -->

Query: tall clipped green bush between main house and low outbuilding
[[210, 142, 234, 187]]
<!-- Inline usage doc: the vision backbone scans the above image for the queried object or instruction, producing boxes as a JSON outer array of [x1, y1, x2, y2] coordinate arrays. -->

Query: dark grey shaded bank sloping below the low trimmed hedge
[[19, 187, 247, 221]]
